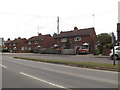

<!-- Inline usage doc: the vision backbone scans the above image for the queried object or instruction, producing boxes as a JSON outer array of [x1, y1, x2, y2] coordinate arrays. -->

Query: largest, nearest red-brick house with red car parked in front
[[54, 27, 97, 52]]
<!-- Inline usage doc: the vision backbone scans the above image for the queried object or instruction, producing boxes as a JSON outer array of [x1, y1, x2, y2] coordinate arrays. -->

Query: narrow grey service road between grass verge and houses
[[4, 53, 118, 64]]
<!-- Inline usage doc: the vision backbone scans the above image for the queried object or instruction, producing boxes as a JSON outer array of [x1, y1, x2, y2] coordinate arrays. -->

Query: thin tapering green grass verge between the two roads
[[14, 57, 120, 71]]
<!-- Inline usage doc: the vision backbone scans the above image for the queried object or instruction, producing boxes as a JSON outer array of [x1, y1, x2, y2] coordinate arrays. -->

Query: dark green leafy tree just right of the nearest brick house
[[97, 33, 112, 53]]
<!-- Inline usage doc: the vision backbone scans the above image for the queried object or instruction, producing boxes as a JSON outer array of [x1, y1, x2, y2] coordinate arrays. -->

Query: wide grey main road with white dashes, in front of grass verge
[[0, 55, 118, 89]]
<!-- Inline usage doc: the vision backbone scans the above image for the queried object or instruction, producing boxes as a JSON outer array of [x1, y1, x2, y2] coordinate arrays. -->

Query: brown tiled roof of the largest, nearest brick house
[[54, 28, 94, 38]]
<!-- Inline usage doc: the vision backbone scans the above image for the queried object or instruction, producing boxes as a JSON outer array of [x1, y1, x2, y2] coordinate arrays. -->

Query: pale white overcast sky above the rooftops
[[0, 0, 120, 40]]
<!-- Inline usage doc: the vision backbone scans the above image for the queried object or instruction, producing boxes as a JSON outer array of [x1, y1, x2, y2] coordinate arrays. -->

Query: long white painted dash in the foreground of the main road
[[20, 72, 66, 88]]
